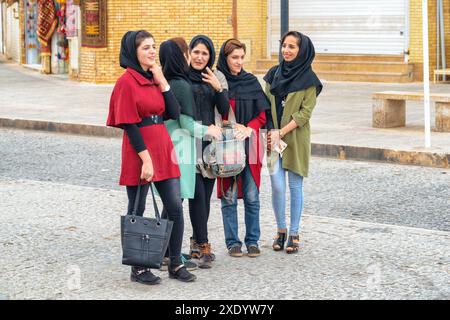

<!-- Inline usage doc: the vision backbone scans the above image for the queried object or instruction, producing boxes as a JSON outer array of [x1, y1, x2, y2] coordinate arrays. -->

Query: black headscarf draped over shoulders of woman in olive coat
[[264, 32, 322, 97]]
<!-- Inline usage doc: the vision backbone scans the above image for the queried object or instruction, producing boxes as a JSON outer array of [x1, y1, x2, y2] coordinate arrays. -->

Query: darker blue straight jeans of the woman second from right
[[221, 165, 260, 249]]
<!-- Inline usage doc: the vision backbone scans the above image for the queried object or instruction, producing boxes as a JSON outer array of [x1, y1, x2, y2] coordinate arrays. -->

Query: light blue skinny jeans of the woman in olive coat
[[270, 158, 303, 235]]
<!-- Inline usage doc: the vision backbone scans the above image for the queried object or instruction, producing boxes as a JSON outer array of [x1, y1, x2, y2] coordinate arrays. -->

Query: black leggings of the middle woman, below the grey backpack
[[189, 173, 216, 243]]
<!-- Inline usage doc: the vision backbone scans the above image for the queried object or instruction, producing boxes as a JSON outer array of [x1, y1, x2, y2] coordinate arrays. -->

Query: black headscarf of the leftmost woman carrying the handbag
[[119, 30, 153, 80]]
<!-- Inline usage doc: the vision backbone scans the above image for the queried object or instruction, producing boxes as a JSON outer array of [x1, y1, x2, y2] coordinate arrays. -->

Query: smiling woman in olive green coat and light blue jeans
[[264, 31, 322, 253]]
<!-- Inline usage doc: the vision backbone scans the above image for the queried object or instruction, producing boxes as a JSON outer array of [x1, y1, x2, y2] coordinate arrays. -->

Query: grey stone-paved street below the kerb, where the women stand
[[0, 129, 450, 299]]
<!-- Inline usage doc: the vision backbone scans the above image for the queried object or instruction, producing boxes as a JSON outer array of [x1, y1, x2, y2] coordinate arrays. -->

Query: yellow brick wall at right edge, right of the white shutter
[[409, 0, 450, 81]]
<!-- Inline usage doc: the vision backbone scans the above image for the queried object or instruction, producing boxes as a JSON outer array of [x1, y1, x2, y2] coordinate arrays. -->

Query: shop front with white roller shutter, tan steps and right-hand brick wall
[[267, 0, 450, 82]]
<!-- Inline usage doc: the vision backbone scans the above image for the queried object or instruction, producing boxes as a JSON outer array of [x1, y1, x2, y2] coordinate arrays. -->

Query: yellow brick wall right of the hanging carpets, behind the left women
[[78, 0, 233, 83]]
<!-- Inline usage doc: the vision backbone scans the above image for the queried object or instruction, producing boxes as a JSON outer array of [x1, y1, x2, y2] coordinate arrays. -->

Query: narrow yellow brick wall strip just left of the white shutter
[[237, 0, 268, 71]]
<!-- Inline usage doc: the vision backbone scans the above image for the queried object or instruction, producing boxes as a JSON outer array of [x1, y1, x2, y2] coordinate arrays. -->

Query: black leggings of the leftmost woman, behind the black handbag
[[127, 178, 184, 268]]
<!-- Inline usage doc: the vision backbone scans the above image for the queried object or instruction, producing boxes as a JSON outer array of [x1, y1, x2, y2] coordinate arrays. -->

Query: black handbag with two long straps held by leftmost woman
[[120, 182, 173, 269]]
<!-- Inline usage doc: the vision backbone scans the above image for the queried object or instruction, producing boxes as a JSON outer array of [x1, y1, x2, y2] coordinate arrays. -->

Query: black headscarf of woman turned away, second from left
[[159, 40, 190, 82]]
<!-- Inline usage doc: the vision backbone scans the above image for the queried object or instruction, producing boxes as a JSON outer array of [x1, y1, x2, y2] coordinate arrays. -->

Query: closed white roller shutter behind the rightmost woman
[[270, 0, 406, 55]]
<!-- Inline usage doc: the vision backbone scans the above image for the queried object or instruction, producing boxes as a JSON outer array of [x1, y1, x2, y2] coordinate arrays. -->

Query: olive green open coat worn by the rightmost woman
[[265, 84, 316, 177]]
